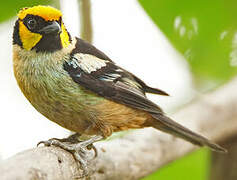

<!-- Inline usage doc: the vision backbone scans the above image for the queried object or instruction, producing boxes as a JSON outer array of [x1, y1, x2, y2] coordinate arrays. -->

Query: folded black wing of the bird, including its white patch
[[64, 53, 163, 113]]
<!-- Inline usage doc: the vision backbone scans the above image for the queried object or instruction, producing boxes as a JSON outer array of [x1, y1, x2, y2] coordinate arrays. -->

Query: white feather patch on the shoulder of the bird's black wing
[[73, 53, 109, 74]]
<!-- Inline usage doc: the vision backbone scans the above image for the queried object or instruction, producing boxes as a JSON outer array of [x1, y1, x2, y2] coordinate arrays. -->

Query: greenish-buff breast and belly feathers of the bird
[[14, 50, 104, 130]]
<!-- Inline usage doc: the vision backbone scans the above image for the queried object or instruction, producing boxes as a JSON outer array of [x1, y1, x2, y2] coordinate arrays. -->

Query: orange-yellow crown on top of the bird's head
[[18, 5, 62, 21]]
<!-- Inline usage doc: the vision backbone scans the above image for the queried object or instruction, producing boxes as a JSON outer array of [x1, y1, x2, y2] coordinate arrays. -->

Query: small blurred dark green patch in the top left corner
[[0, 0, 52, 22]]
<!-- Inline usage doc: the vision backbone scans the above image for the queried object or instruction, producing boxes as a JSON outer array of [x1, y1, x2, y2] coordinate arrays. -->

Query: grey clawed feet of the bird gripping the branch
[[38, 134, 104, 176]]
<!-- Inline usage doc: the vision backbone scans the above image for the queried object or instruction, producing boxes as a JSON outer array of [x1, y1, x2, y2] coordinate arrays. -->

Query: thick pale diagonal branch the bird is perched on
[[0, 78, 237, 180]]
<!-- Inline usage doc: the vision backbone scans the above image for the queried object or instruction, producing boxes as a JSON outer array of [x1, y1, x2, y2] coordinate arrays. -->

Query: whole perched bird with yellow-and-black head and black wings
[[13, 5, 226, 176]]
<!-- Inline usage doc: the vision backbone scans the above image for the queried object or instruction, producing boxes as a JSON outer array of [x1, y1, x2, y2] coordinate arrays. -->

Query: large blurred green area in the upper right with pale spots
[[139, 0, 237, 86]]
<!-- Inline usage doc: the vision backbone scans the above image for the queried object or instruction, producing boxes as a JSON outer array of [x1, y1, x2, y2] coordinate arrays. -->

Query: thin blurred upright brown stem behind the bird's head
[[79, 0, 93, 42]]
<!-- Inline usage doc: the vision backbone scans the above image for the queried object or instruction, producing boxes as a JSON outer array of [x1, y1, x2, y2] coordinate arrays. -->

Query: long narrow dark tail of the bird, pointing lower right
[[152, 114, 227, 153]]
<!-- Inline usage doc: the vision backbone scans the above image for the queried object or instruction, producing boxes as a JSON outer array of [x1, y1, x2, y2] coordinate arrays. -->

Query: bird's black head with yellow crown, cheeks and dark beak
[[13, 6, 71, 52]]
